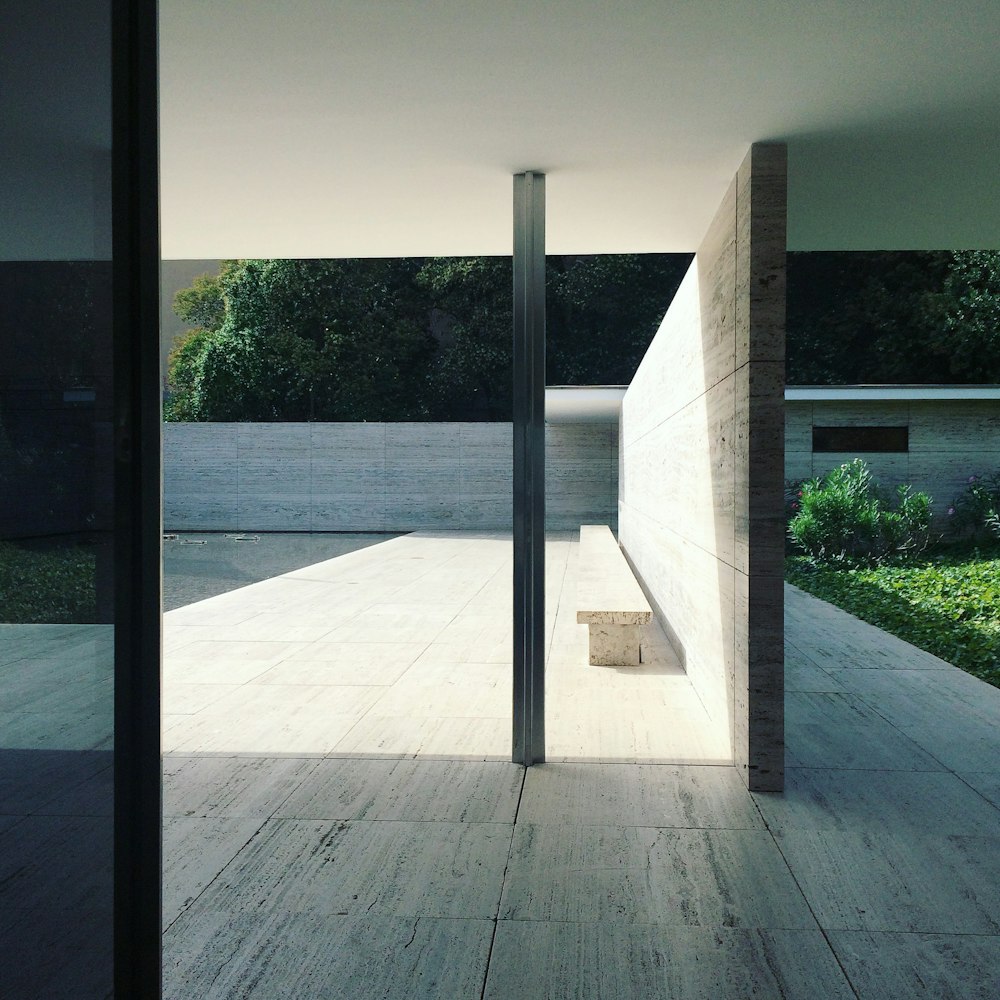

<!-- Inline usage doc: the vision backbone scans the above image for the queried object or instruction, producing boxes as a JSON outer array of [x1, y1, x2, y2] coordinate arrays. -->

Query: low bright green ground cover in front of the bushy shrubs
[[785, 548, 1000, 687]]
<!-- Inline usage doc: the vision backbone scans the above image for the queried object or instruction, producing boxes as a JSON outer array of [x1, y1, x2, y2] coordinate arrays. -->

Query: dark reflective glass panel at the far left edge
[[0, 0, 114, 1000]]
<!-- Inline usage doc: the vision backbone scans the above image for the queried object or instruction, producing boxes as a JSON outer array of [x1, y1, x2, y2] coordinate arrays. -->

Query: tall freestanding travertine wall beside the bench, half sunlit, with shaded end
[[619, 145, 785, 790]]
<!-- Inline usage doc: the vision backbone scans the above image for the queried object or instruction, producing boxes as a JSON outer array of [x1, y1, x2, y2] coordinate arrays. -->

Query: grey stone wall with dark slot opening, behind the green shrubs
[[785, 399, 1000, 516]]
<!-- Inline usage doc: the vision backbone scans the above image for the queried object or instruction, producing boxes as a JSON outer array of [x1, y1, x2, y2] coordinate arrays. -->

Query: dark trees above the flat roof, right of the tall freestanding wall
[[787, 250, 1000, 385]]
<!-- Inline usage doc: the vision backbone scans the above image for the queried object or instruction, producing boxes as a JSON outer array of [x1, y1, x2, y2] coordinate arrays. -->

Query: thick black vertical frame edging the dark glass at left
[[112, 0, 162, 1000]]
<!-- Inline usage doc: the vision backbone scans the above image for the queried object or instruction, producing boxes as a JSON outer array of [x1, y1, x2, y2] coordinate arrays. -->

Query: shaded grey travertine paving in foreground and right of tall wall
[[154, 548, 1000, 1000]]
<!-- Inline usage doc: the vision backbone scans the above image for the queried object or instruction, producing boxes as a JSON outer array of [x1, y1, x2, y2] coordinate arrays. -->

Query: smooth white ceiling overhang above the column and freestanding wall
[[160, 0, 1000, 258]]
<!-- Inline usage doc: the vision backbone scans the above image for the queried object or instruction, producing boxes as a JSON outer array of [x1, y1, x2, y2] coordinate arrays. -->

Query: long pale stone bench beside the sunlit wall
[[576, 524, 653, 667]]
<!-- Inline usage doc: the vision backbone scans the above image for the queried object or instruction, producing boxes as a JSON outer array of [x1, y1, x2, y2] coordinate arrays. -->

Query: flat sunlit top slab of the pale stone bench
[[576, 524, 653, 625]]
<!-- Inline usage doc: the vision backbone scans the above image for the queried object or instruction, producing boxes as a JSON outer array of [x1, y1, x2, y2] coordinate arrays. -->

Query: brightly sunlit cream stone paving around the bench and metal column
[[163, 532, 731, 763]]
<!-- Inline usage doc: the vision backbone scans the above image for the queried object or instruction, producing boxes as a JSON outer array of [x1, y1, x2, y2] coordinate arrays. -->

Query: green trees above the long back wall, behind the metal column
[[165, 254, 690, 420]]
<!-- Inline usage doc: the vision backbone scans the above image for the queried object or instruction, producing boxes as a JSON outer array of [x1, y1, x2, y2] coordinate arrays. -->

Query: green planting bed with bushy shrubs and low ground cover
[[785, 460, 1000, 687]]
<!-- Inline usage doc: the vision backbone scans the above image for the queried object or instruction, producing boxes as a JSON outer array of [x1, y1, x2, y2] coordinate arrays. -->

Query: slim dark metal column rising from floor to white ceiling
[[512, 173, 545, 764]]
